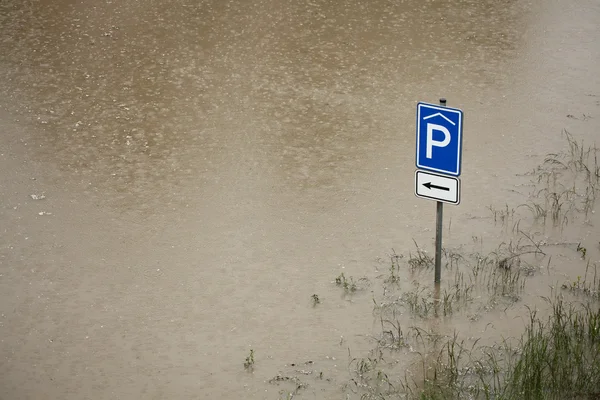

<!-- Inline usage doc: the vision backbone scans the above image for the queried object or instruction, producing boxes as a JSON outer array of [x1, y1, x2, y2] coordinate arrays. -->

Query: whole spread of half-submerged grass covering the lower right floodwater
[[268, 132, 600, 400]]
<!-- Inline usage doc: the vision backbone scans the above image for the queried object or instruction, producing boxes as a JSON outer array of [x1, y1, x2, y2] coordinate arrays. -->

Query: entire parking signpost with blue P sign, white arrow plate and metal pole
[[415, 99, 463, 285]]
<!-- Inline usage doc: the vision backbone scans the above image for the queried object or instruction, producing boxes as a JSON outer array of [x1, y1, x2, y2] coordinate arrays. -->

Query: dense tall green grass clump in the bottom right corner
[[503, 299, 600, 400]]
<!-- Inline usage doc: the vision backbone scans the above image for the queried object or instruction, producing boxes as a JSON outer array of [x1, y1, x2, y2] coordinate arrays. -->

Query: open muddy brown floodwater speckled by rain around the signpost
[[0, 0, 600, 400]]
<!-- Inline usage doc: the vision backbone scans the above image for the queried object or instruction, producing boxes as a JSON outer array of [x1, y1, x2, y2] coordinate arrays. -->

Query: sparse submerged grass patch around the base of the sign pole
[[384, 234, 545, 318]]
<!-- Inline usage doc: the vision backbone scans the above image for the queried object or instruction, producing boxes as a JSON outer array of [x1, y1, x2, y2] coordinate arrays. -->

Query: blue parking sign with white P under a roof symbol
[[417, 102, 463, 176]]
